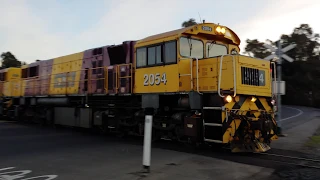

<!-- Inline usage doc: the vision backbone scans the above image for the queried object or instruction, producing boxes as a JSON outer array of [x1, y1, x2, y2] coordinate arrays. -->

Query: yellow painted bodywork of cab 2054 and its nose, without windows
[[134, 23, 271, 97]]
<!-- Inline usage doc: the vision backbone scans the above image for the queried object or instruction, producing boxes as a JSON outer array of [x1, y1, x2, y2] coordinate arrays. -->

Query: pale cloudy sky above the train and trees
[[0, 0, 320, 63]]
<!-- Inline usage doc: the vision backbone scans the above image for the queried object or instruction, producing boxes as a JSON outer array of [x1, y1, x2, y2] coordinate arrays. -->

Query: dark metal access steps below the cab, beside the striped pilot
[[202, 95, 223, 143]]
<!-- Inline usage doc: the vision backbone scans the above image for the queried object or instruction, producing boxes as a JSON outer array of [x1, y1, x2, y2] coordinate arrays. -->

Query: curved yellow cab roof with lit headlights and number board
[[137, 23, 241, 45]]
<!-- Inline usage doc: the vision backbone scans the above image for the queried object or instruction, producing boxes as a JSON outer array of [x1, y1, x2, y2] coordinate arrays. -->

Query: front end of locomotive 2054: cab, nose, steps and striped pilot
[[134, 23, 277, 152]]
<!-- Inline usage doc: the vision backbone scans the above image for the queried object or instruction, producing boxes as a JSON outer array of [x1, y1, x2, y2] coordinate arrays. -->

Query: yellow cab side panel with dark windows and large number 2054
[[134, 40, 179, 93]]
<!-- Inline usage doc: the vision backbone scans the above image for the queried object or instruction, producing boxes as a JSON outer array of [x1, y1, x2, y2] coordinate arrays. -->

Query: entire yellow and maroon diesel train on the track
[[0, 22, 278, 152]]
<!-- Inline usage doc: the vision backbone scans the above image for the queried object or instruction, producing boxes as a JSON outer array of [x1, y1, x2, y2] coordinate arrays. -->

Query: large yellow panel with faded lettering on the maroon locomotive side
[[49, 52, 83, 95]]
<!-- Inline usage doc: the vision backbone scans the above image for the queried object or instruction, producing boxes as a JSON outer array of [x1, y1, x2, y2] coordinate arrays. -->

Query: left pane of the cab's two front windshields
[[180, 37, 203, 59]]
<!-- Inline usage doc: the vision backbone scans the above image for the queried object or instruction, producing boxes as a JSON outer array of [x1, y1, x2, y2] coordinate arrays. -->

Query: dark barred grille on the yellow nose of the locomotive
[[241, 67, 265, 86]]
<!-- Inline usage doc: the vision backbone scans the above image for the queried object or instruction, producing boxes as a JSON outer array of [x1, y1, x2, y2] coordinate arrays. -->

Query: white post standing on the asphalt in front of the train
[[142, 110, 153, 172]]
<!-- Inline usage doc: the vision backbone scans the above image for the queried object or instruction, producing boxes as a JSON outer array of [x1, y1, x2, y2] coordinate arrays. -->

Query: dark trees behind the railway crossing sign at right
[[245, 24, 320, 107]]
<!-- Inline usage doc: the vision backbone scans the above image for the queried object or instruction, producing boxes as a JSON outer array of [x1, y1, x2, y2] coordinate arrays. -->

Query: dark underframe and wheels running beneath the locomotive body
[[3, 92, 275, 151]]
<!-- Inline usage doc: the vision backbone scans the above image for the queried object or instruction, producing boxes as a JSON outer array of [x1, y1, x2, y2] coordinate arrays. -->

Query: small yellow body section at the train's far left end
[[2, 68, 21, 97]]
